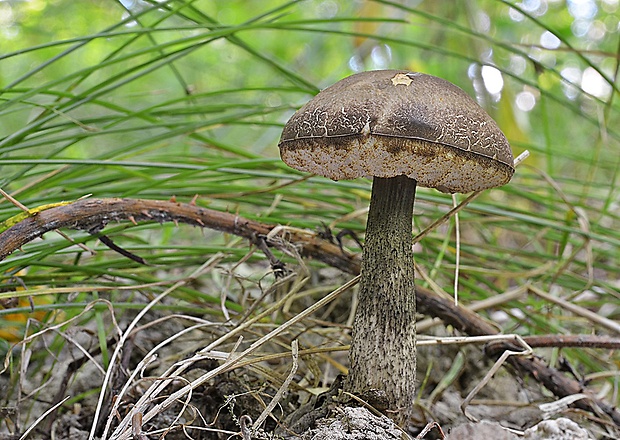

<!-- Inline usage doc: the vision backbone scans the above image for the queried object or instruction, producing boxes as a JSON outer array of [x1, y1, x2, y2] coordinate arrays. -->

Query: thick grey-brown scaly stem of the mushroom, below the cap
[[345, 176, 416, 424]]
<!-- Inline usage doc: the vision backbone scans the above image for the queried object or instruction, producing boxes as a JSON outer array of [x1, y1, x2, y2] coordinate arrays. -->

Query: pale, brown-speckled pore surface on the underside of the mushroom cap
[[280, 135, 512, 193]]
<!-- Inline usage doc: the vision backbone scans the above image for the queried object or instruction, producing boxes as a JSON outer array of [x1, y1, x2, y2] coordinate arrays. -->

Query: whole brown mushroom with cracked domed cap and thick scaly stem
[[279, 70, 514, 424]]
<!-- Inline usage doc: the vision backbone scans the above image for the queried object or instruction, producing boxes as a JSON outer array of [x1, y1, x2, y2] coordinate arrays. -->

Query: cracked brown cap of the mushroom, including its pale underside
[[279, 70, 514, 193]]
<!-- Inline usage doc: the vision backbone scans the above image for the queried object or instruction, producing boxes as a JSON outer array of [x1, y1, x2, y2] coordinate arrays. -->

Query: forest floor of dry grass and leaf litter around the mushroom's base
[[0, 269, 618, 440]]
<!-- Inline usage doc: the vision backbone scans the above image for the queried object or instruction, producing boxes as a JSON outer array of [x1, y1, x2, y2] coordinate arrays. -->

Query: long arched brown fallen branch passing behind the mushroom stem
[[0, 199, 620, 426]]
